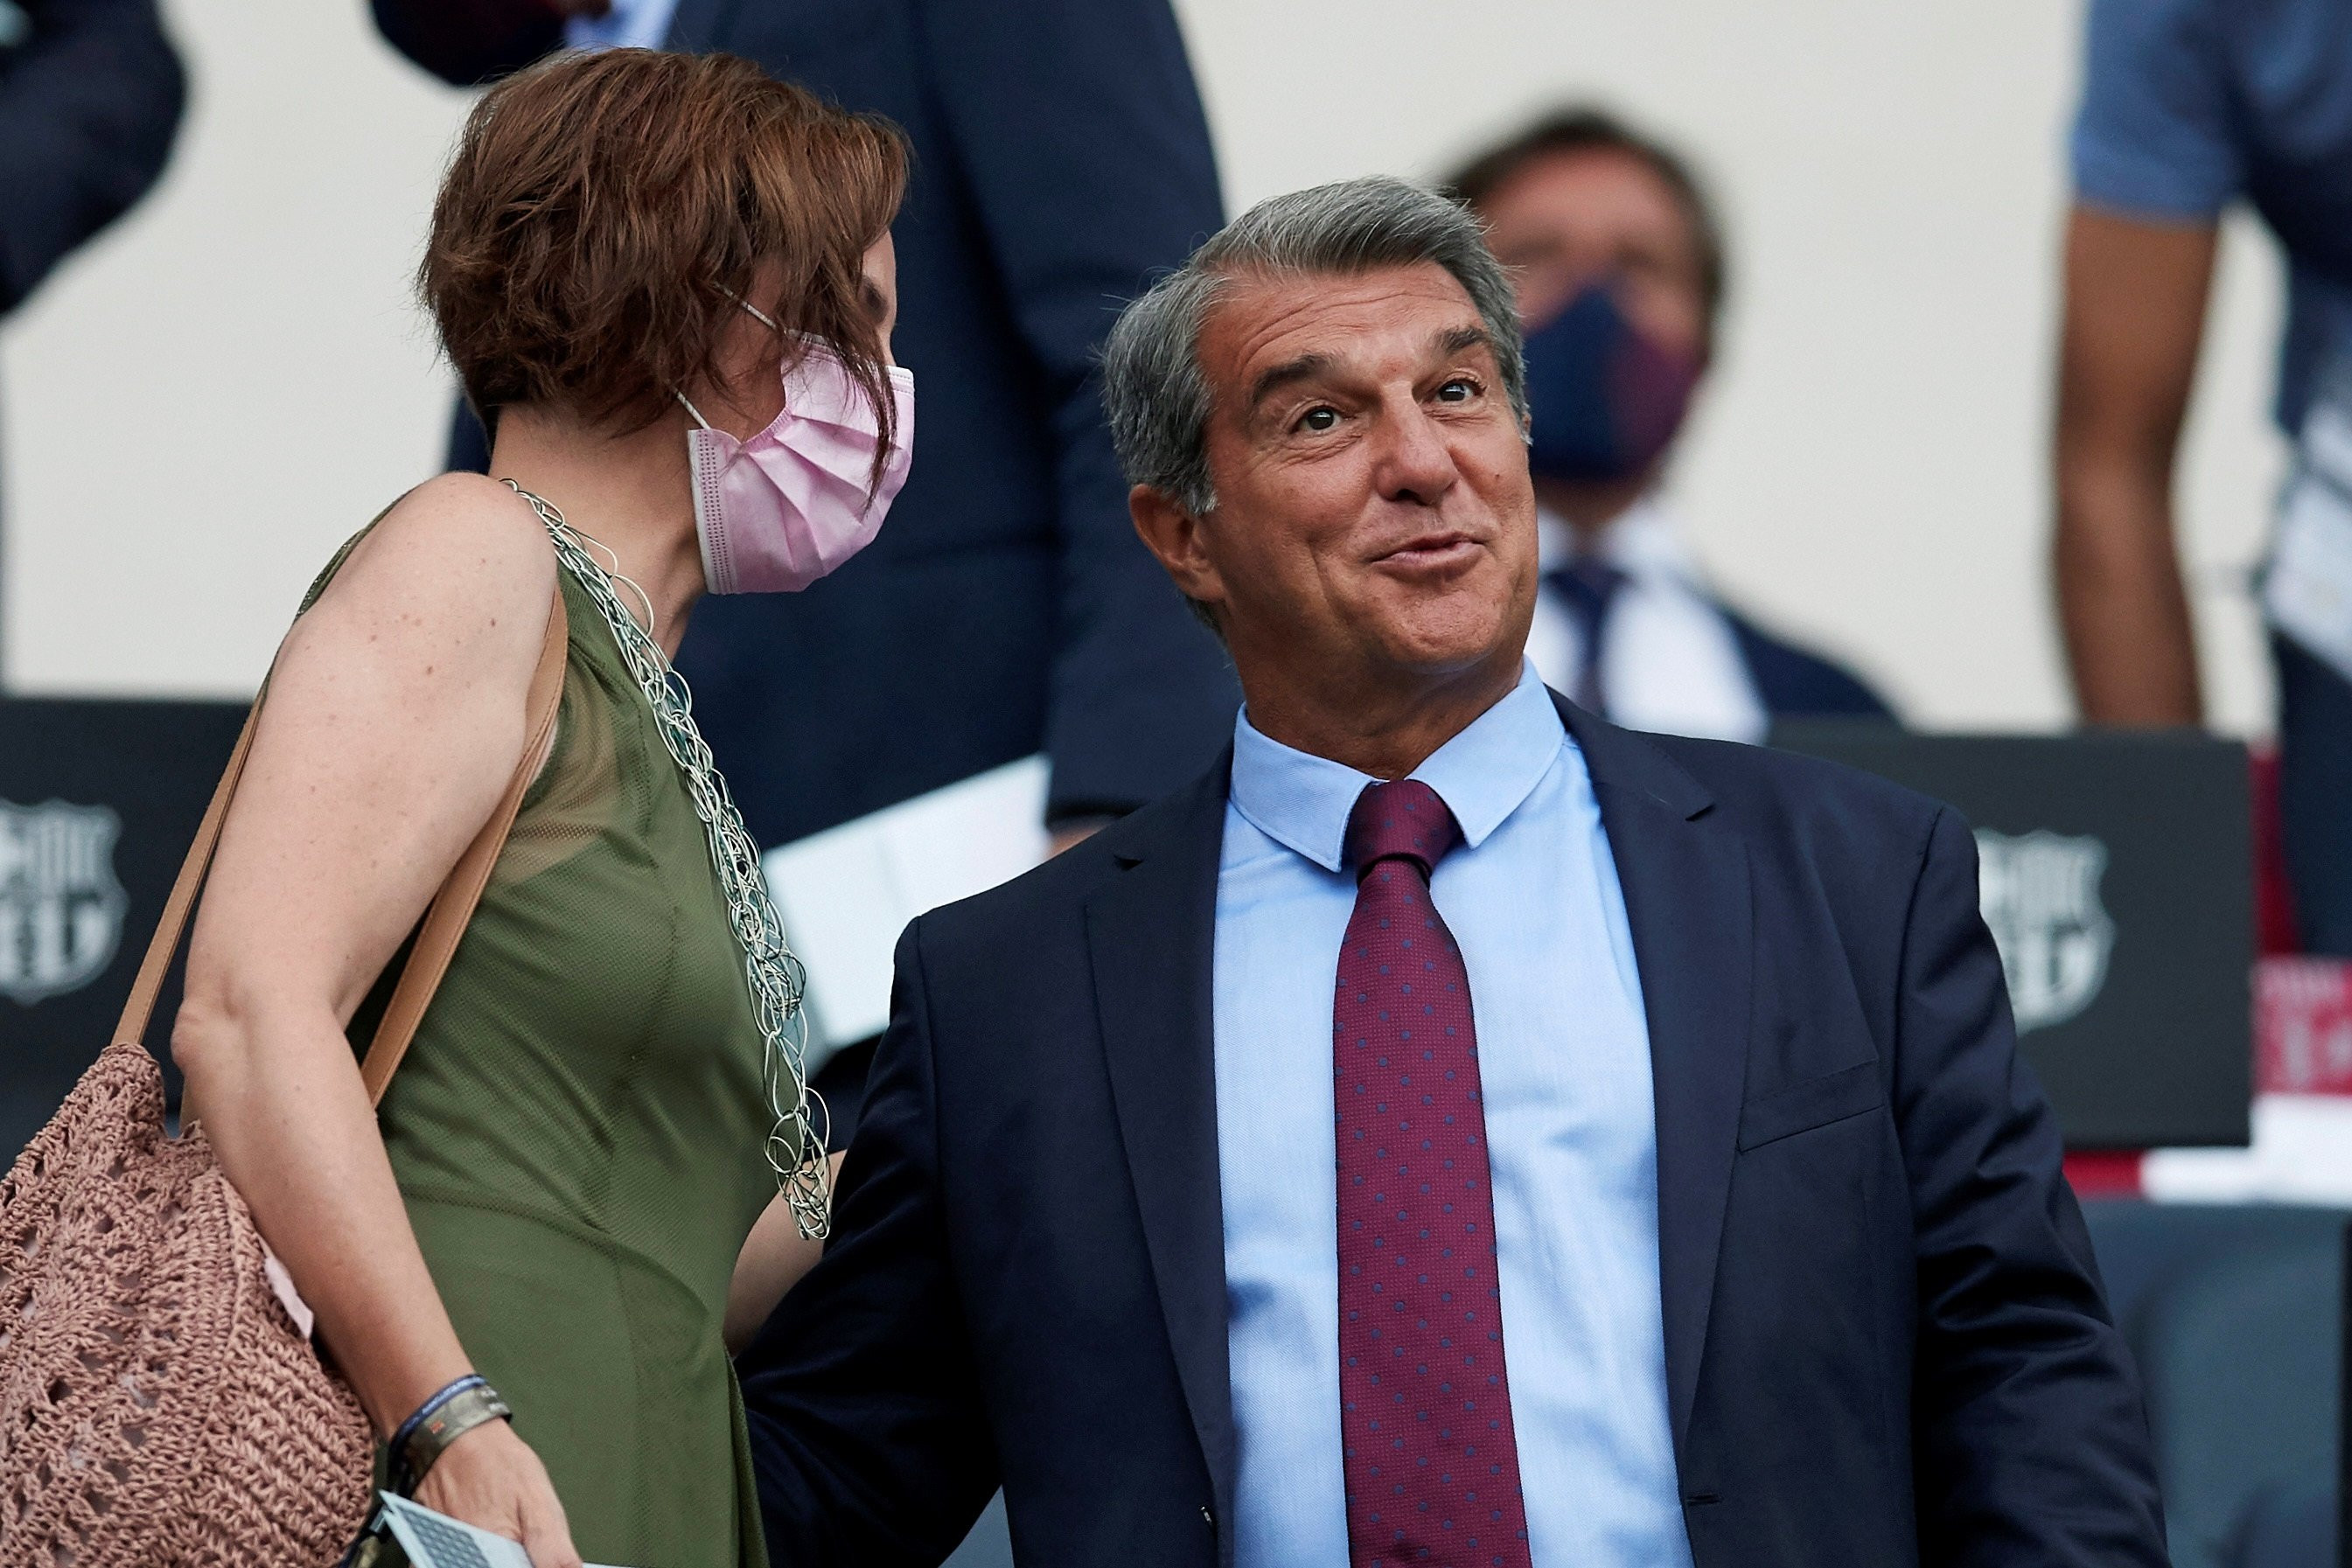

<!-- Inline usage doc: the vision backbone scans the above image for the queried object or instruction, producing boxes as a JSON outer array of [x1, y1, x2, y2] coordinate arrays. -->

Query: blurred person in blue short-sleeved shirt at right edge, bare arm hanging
[[2055, 0, 2352, 954]]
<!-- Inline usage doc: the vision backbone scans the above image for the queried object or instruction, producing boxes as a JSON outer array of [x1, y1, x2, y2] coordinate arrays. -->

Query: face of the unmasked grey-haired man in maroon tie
[[1136, 263, 1536, 684]]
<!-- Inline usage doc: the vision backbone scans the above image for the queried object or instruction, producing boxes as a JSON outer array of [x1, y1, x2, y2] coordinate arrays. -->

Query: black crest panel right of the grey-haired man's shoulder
[[1771, 721, 2253, 1150]]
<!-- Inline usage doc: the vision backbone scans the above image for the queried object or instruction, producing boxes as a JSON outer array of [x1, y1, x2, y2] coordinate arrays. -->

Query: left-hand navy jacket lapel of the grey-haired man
[[1086, 770, 1232, 1542]]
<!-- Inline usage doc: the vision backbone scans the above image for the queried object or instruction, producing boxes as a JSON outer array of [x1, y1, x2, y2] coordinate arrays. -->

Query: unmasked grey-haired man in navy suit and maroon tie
[[738, 178, 2164, 1568]]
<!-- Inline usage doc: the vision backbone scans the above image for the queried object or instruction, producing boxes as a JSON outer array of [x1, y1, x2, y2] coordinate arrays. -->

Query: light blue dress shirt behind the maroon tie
[[1214, 667, 1691, 1568]]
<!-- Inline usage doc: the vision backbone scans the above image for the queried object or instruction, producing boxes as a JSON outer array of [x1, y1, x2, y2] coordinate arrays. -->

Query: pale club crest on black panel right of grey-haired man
[[1976, 827, 2114, 1035]]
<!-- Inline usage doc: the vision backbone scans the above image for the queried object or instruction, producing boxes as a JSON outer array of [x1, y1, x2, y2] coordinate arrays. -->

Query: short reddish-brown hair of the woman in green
[[416, 49, 908, 446]]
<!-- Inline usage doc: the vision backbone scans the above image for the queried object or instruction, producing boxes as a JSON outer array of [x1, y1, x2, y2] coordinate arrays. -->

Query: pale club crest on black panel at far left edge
[[0, 799, 125, 1004]]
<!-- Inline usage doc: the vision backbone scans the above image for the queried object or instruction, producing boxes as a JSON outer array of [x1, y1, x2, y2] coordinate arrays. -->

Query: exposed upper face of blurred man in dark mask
[[1479, 148, 1707, 358]]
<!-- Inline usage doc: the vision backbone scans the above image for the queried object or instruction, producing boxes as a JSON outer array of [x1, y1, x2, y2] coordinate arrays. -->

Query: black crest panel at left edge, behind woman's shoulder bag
[[0, 698, 245, 1159]]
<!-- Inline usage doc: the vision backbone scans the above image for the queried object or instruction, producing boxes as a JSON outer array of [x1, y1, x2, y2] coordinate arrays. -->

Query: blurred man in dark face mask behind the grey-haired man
[[1448, 108, 1891, 741]]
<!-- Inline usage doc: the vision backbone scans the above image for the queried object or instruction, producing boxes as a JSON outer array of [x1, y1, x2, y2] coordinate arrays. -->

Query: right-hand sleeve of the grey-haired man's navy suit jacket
[[1894, 811, 2167, 1568]]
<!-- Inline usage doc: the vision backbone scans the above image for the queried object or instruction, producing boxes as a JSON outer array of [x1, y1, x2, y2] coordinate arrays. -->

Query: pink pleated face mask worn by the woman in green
[[677, 319, 915, 592]]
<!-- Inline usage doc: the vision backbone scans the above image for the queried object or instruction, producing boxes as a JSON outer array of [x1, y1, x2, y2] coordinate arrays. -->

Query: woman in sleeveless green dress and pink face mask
[[171, 49, 912, 1568]]
